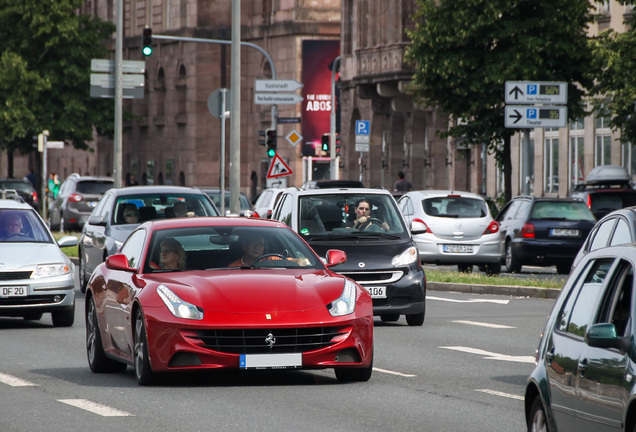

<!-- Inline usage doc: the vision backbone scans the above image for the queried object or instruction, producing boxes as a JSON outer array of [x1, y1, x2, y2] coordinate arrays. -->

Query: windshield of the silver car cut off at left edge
[[0, 209, 53, 243]]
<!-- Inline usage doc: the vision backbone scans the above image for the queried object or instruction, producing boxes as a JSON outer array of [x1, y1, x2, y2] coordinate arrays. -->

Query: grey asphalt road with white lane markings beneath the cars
[[0, 282, 553, 432]]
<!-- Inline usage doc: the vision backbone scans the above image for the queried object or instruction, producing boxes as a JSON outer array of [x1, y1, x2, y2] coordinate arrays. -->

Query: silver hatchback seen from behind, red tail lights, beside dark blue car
[[398, 190, 503, 274]]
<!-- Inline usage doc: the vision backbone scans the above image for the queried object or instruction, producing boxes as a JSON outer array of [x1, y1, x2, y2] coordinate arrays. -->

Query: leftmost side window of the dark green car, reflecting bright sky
[[556, 259, 614, 337]]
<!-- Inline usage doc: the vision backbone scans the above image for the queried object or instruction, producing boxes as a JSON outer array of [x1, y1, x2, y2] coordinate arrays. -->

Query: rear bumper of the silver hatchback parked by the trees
[[414, 235, 503, 265]]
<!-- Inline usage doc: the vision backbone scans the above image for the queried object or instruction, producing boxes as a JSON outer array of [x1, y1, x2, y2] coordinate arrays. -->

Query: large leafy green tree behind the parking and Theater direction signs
[[407, 0, 594, 201]]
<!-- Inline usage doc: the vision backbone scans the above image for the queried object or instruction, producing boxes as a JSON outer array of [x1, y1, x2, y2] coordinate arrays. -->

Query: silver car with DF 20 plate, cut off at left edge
[[0, 199, 78, 327]]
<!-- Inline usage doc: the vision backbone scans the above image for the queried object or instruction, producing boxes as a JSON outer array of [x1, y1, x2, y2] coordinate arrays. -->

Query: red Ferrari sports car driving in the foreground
[[85, 217, 373, 385]]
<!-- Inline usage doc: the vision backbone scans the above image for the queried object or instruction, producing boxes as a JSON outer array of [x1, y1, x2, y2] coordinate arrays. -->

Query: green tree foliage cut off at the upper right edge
[[593, 1, 636, 147]]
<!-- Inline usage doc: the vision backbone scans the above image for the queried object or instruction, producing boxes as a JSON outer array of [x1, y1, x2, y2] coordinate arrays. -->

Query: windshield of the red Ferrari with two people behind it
[[144, 225, 324, 273]]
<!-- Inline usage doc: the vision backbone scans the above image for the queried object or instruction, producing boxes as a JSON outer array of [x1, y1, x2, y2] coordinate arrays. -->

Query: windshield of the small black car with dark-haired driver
[[298, 193, 409, 239]]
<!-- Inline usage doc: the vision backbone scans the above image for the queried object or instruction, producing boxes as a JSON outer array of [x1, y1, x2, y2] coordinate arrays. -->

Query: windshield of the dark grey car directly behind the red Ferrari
[[113, 193, 219, 225]]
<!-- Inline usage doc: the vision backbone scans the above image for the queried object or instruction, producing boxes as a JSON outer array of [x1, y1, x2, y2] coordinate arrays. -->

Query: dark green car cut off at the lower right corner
[[525, 244, 636, 432]]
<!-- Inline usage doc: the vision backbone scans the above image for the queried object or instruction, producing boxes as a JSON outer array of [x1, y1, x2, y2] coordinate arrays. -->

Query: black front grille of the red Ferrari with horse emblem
[[197, 327, 347, 354]]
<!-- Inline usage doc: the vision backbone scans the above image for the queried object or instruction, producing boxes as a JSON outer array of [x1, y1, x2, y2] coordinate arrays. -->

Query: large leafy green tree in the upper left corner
[[0, 0, 114, 160]]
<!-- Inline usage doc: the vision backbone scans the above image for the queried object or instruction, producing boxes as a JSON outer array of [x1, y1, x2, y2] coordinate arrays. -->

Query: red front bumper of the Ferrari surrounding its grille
[[144, 308, 373, 372]]
